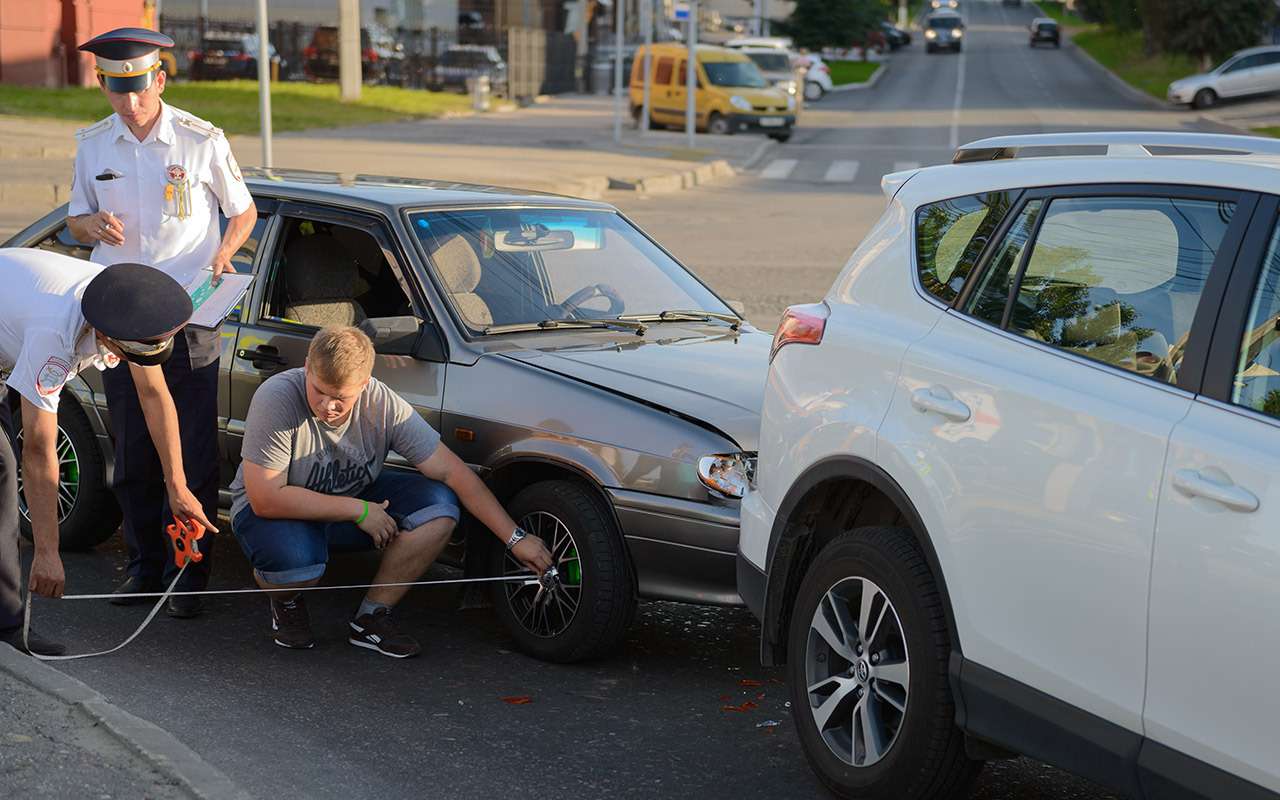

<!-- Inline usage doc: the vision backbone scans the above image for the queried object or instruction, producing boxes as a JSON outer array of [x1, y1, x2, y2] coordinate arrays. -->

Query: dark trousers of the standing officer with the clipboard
[[102, 334, 220, 590]]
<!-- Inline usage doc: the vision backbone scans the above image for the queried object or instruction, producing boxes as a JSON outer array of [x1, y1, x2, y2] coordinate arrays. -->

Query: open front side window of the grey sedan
[[264, 218, 413, 328]]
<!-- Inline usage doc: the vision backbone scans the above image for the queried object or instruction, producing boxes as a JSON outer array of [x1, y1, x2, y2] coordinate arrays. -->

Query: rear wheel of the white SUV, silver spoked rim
[[787, 527, 982, 800]]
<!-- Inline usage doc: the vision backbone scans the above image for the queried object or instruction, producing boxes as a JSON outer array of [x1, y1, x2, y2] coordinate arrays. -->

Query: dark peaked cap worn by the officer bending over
[[81, 264, 192, 366]]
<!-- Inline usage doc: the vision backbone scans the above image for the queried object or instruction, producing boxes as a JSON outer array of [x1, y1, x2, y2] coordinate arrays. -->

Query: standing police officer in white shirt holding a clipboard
[[68, 28, 257, 617]]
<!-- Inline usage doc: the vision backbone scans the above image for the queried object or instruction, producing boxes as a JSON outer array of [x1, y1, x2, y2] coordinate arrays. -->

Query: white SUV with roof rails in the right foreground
[[739, 133, 1280, 800]]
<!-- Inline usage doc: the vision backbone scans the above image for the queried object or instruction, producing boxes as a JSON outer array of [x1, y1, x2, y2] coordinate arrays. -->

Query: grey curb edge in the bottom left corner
[[0, 645, 252, 800]]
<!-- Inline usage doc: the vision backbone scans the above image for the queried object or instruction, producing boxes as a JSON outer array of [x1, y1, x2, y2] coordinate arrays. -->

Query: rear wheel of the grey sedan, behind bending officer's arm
[[10, 396, 122, 550]]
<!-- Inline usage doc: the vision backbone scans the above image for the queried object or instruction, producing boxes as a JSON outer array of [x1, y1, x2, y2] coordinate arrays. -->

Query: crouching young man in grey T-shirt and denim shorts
[[232, 326, 552, 658]]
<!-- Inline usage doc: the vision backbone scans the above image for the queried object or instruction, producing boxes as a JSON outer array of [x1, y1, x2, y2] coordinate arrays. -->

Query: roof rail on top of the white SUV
[[951, 131, 1280, 164]]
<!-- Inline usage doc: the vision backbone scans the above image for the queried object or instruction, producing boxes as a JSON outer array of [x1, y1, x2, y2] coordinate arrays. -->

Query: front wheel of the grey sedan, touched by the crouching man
[[490, 480, 636, 663]]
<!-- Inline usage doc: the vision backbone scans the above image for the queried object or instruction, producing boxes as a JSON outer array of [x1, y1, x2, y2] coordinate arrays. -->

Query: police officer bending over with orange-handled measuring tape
[[0, 248, 211, 655]]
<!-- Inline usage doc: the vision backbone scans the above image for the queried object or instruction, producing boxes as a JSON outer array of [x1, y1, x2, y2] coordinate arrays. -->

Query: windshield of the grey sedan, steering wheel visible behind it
[[410, 209, 732, 334]]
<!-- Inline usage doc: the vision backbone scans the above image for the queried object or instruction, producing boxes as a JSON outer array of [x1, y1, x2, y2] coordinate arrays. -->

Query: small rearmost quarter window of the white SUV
[[915, 192, 1011, 303]]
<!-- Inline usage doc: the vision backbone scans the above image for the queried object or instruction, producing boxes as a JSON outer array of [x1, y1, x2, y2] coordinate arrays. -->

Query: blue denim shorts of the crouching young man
[[232, 470, 458, 584]]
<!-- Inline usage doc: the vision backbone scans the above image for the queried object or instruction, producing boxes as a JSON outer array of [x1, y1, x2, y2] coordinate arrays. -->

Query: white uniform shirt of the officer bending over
[[0, 247, 118, 412]]
